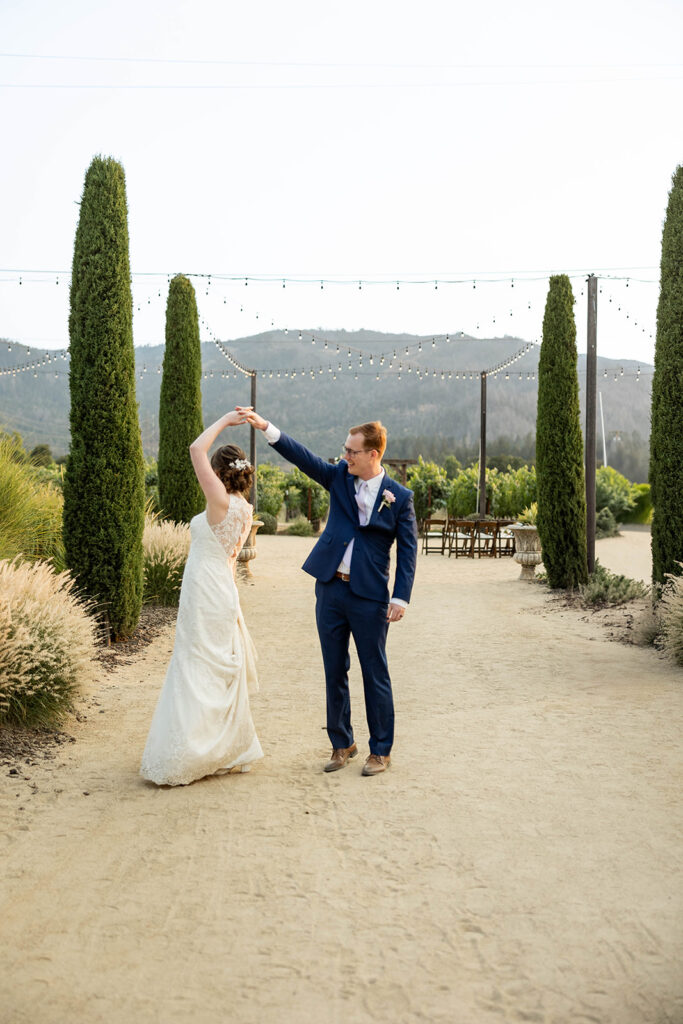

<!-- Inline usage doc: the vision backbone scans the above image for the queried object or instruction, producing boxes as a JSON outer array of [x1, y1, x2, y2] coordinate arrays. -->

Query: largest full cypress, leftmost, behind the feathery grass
[[63, 157, 144, 640]]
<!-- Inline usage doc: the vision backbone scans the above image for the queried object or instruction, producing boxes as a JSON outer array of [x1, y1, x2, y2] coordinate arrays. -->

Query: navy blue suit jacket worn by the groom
[[272, 433, 418, 604]]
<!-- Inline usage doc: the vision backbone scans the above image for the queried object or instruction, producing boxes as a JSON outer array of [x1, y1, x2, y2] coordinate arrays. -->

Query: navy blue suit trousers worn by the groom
[[315, 578, 394, 755]]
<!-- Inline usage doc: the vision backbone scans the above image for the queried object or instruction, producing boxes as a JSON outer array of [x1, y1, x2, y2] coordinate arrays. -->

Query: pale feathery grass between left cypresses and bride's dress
[[142, 510, 189, 607]]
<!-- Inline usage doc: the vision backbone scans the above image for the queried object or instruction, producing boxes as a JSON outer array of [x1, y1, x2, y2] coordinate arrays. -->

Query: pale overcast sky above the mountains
[[0, 0, 683, 366]]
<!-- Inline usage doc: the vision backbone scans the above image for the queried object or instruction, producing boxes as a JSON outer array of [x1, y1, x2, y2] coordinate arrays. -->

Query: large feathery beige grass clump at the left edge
[[0, 559, 98, 727]]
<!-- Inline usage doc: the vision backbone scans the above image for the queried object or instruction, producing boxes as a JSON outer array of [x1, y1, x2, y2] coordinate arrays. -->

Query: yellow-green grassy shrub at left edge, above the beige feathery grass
[[0, 437, 65, 571]]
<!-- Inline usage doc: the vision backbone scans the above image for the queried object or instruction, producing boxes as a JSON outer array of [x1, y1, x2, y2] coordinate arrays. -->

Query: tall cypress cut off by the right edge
[[650, 166, 683, 593]]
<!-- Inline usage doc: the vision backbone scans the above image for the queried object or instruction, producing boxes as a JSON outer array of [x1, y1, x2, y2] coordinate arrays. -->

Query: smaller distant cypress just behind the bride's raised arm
[[159, 273, 205, 522]]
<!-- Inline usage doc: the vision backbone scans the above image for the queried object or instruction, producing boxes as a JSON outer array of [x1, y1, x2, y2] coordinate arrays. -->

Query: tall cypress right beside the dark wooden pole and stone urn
[[536, 274, 588, 589]]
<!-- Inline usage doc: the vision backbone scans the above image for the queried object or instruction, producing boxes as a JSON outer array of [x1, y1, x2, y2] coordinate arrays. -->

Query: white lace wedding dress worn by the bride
[[140, 495, 263, 785]]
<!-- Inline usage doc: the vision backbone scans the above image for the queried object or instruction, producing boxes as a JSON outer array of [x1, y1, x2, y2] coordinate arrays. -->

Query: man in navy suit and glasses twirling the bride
[[242, 409, 418, 775]]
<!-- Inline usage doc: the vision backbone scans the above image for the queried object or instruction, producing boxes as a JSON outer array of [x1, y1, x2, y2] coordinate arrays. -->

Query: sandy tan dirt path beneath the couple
[[0, 537, 683, 1024]]
